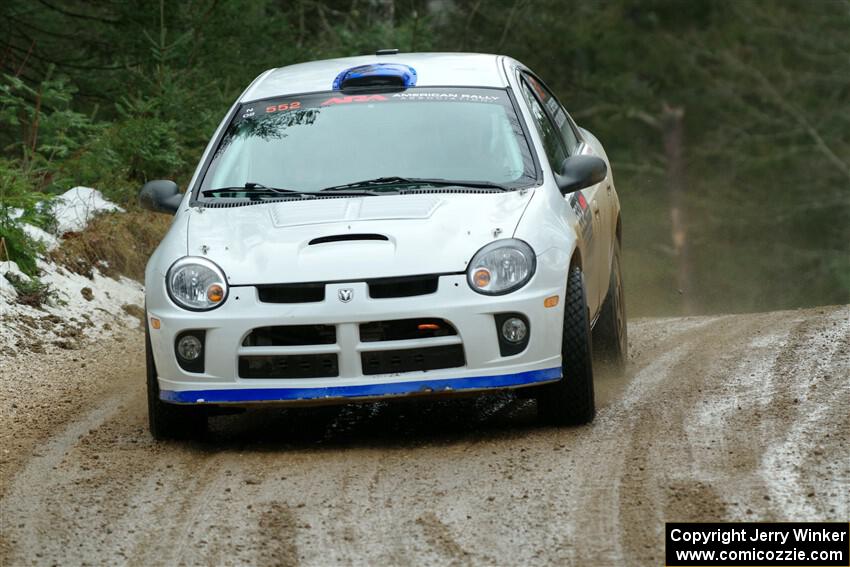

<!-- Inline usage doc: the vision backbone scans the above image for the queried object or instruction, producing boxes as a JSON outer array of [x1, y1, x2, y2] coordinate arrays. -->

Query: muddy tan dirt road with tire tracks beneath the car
[[0, 307, 850, 565]]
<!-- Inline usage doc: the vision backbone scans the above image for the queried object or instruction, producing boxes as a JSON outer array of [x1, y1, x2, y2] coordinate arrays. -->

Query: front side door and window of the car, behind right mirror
[[521, 72, 608, 316]]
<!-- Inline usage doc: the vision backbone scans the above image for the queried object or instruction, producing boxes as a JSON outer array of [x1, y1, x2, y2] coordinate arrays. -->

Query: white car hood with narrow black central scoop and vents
[[187, 191, 534, 285]]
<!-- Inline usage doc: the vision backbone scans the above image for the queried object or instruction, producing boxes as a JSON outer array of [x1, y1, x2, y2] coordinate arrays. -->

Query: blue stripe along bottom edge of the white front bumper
[[159, 367, 561, 404]]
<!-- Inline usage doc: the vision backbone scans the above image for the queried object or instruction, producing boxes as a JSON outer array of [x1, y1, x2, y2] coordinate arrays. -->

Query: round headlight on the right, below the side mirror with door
[[466, 238, 537, 295]]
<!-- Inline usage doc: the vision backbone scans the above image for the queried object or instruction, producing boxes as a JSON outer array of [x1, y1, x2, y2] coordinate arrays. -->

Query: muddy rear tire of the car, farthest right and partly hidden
[[593, 242, 629, 375]]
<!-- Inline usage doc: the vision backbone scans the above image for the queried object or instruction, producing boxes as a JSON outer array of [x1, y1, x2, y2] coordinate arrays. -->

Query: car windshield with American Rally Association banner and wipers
[[195, 88, 536, 198]]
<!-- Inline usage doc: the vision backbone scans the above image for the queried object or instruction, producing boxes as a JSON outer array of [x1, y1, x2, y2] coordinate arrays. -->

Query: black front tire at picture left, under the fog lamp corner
[[145, 316, 207, 440]]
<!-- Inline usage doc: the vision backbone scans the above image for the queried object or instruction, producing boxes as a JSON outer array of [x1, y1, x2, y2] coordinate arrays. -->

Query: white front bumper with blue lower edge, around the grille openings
[[147, 262, 565, 405]]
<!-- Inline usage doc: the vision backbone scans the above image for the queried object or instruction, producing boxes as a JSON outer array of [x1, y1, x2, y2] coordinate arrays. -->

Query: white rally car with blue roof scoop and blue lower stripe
[[140, 51, 627, 438]]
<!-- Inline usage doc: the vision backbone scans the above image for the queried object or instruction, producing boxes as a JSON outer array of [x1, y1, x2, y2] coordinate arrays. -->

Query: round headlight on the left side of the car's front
[[165, 256, 227, 311]]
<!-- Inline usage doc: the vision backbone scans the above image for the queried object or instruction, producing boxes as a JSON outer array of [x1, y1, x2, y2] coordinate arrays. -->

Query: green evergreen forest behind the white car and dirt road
[[0, 0, 850, 316]]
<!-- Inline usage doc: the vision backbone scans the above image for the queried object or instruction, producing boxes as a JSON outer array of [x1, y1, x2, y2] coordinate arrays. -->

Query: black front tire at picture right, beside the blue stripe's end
[[537, 268, 596, 425]]
